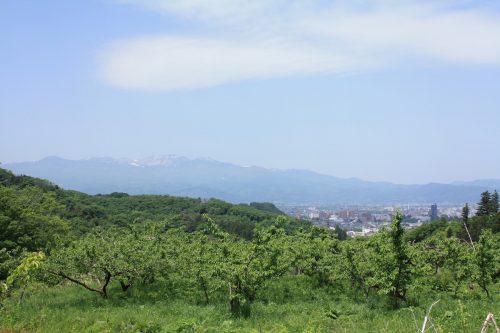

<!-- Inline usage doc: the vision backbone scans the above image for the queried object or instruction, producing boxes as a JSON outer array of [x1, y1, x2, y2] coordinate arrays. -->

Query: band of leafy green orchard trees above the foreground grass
[[7, 214, 500, 317]]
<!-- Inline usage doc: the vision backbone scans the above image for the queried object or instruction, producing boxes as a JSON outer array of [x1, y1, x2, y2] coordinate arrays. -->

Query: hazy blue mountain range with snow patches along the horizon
[[1, 155, 500, 205]]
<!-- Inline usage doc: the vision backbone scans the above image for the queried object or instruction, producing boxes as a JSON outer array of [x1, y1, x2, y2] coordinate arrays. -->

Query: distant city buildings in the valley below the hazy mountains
[[280, 204, 476, 236]]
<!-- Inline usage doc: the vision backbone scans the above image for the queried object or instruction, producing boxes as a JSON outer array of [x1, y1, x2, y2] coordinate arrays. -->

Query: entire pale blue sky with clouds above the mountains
[[0, 0, 500, 184]]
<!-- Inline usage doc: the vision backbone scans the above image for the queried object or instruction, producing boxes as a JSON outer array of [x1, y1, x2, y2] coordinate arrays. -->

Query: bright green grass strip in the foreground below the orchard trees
[[0, 281, 500, 333]]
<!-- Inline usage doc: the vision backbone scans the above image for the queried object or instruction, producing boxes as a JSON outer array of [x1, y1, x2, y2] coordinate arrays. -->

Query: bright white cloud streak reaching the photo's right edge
[[302, 5, 500, 65]]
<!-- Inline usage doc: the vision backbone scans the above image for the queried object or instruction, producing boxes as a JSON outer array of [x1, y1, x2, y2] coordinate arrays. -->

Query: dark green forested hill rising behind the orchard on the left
[[0, 168, 310, 251]]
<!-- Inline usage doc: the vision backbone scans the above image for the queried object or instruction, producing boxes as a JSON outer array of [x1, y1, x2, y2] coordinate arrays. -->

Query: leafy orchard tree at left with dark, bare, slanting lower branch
[[46, 229, 161, 298]]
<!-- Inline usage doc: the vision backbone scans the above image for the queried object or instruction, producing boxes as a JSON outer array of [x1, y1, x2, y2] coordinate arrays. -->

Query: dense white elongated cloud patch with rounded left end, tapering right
[[99, 37, 359, 90]]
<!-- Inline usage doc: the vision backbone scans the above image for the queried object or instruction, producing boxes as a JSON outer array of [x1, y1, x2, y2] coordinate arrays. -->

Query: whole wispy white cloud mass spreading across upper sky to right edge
[[101, 0, 500, 90]]
